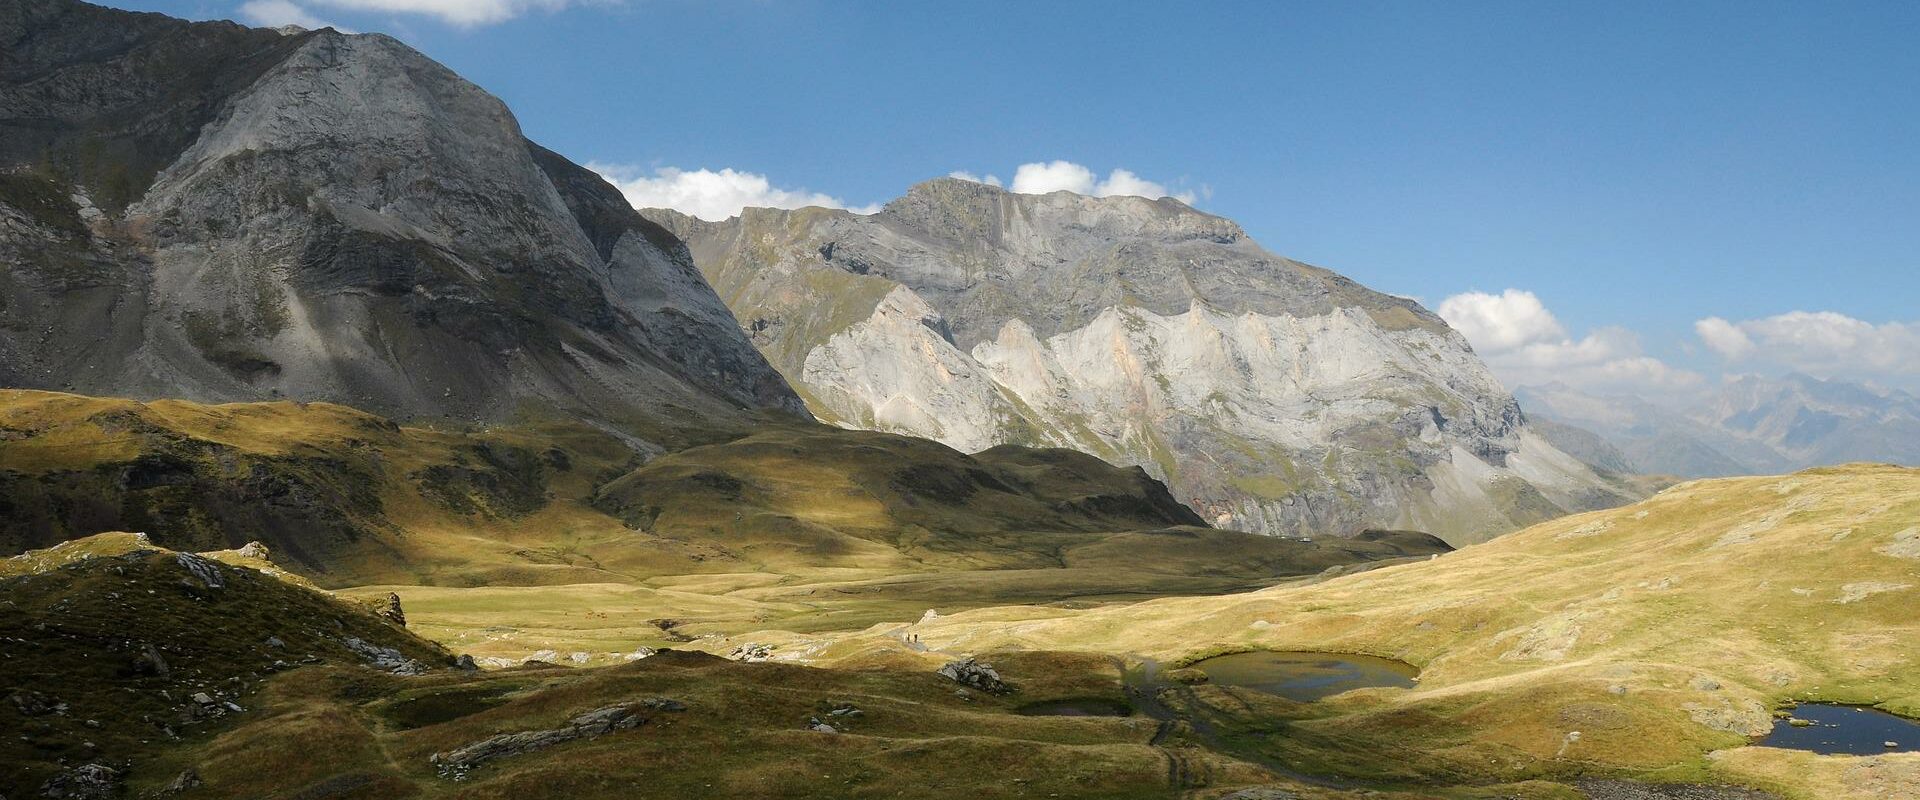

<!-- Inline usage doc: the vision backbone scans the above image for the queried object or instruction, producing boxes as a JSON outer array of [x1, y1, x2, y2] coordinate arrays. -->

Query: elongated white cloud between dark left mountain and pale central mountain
[[588, 163, 879, 223]]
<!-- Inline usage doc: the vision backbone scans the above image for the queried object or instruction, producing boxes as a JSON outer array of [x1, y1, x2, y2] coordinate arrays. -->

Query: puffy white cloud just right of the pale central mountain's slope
[[1438, 290, 1705, 395]]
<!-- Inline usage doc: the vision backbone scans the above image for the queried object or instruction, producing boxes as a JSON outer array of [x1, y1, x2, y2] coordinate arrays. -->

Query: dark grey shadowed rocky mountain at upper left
[[0, 0, 804, 437]]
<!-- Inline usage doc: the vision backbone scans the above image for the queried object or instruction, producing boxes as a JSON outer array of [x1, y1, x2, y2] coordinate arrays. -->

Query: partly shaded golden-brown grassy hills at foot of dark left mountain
[[0, 391, 1444, 660]]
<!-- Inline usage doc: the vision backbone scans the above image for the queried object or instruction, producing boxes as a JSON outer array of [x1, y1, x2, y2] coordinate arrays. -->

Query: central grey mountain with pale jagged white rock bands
[[643, 178, 1630, 543]]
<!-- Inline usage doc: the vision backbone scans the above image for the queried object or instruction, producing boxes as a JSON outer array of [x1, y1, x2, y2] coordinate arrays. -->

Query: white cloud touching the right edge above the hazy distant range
[[1693, 311, 1920, 380]]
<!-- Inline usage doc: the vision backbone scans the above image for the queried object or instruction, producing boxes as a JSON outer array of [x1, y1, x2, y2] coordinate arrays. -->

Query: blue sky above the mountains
[[111, 0, 1920, 391]]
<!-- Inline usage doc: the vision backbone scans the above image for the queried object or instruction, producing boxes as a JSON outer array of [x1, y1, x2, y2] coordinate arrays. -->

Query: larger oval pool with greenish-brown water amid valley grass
[[1192, 650, 1419, 702]]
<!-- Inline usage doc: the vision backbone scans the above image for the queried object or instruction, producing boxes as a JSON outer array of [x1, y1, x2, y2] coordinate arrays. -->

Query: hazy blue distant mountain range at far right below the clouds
[[1515, 374, 1920, 478]]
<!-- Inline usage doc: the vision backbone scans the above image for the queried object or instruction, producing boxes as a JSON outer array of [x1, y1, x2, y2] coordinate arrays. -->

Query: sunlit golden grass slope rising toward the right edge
[[826, 464, 1920, 798]]
